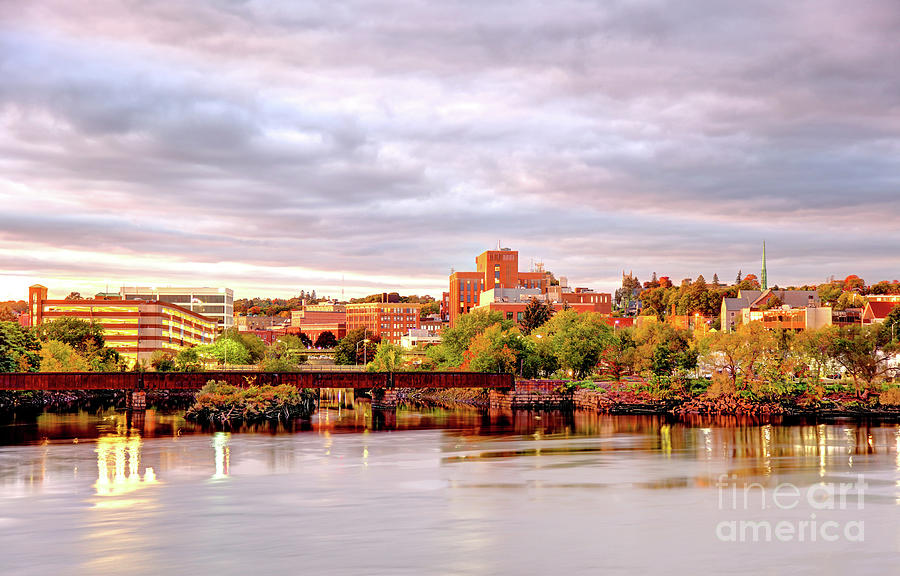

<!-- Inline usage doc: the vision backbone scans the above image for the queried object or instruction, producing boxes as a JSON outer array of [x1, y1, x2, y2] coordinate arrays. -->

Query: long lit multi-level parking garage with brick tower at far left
[[28, 284, 217, 364]]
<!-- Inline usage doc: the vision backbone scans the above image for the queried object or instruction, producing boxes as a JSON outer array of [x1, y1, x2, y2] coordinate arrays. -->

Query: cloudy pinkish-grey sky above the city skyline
[[0, 0, 900, 300]]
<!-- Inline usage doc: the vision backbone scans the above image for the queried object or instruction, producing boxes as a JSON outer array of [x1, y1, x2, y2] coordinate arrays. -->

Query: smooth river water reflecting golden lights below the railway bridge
[[0, 402, 900, 574]]
